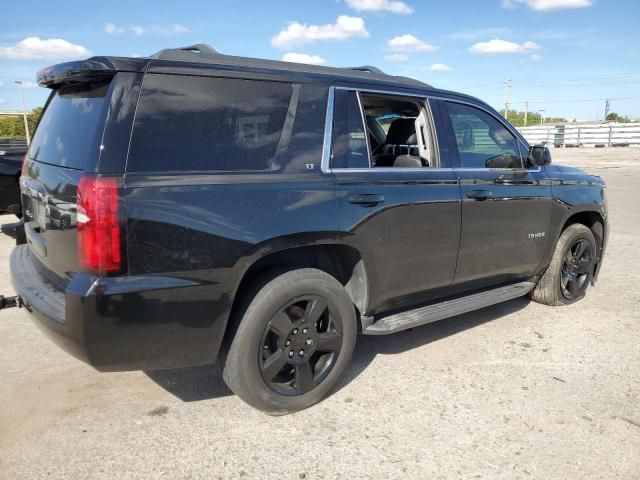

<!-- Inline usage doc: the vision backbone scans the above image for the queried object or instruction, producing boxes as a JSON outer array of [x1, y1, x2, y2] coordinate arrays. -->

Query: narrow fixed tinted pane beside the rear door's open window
[[331, 90, 369, 168]]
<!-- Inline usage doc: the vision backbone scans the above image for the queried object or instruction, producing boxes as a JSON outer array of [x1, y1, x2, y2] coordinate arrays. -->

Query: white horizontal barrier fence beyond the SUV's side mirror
[[518, 122, 640, 147]]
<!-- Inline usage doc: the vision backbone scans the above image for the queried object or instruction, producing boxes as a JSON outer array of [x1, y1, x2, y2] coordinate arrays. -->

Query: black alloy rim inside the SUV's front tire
[[560, 238, 594, 300]]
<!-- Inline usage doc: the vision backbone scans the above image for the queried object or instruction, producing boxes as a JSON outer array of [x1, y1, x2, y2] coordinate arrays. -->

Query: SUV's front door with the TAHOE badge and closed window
[[440, 97, 551, 286]]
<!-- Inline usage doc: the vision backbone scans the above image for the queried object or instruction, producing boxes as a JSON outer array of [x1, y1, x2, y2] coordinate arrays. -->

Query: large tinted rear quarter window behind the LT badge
[[127, 74, 292, 172]]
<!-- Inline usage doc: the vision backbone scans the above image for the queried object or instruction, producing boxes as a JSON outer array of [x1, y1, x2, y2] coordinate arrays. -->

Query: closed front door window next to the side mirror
[[445, 102, 522, 168]]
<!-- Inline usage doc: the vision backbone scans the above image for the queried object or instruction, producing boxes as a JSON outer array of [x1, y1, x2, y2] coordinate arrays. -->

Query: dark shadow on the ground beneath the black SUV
[[145, 297, 529, 402]]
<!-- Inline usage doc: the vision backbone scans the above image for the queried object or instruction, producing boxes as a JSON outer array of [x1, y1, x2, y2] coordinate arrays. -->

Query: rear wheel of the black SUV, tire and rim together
[[220, 268, 357, 415]]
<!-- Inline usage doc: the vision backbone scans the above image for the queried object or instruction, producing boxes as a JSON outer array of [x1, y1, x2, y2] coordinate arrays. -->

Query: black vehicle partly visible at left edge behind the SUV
[[0, 139, 27, 217]]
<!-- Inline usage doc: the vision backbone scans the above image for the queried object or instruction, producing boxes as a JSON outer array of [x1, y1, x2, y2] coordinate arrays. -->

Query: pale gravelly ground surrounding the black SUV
[[0, 149, 640, 479]]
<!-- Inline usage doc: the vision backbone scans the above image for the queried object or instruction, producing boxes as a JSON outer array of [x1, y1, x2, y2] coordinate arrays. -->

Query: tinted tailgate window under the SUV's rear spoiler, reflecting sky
[[29, 81, 109, 170]]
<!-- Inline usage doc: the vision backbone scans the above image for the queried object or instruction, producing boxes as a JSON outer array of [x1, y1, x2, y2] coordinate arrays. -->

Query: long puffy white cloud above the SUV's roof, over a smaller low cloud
[[271, 15, 369, 50]]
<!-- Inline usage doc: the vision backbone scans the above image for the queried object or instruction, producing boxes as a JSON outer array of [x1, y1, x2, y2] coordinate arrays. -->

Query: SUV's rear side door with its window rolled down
[[331, 89, 460, 313]]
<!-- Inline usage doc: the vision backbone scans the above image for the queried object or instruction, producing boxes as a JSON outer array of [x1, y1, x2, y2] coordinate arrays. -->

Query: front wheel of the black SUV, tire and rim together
[[530, 223, 597, 306]]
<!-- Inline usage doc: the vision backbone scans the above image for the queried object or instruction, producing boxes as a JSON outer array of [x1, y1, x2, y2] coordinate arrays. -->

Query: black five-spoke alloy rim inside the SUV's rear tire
[[258, 295, 343, 396]]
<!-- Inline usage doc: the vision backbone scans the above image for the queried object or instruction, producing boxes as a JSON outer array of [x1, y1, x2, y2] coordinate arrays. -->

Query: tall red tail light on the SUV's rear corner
[[77, 176, 122, 274]]
